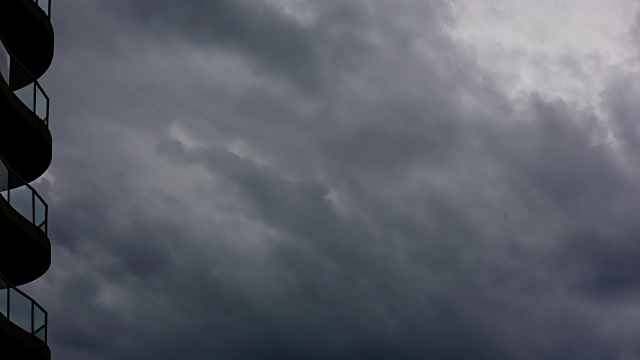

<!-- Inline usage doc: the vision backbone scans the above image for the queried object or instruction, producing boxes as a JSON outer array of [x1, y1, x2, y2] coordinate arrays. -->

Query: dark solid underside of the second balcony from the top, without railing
[[0, 78, 52, 186]]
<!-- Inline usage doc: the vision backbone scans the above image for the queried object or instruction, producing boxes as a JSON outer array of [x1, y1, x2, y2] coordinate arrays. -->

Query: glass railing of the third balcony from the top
[[0, 156, 49, 235]]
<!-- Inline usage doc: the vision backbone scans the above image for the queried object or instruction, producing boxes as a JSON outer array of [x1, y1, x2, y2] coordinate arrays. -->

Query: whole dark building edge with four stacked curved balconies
[[0, 0, 53, 360]]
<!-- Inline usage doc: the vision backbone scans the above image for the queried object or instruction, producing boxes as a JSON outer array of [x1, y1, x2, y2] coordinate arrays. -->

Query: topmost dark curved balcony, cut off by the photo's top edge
[[0, 0, 53, 78]]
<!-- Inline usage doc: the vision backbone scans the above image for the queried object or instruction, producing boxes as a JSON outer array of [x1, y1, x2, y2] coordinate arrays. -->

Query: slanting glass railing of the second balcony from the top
[[0, 37, 49, 126]]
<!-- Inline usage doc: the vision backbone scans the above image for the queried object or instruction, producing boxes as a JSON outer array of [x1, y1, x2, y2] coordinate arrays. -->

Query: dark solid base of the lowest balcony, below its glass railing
[[0, 314, 51, 360]]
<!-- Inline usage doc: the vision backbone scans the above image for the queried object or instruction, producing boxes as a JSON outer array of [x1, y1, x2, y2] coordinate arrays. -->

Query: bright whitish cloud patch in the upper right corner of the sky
[[451, 0, 640, 109]]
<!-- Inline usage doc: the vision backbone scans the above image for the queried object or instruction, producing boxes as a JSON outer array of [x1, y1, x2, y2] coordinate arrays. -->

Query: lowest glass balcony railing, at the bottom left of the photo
[[0, 274, 48, 344]]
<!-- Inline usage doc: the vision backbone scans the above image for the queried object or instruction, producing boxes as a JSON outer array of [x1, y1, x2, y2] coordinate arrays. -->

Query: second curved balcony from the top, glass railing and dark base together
[[0, 36, 52, 182]]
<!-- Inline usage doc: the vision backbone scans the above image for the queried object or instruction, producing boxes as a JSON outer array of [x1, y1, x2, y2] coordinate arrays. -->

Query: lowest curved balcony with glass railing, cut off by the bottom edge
[[0, 274, 51, 360]]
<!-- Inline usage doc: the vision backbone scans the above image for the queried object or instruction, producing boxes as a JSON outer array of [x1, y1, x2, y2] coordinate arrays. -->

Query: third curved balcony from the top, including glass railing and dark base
[[0, 156, 51, 285]]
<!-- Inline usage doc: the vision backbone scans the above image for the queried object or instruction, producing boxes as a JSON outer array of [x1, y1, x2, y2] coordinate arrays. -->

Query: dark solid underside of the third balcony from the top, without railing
[[0, 197, 51, 286]]
